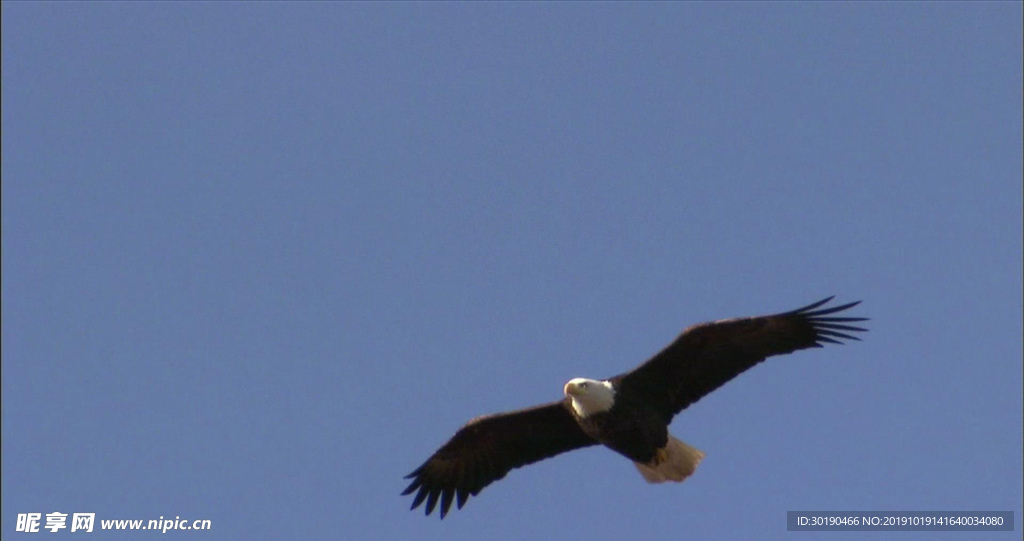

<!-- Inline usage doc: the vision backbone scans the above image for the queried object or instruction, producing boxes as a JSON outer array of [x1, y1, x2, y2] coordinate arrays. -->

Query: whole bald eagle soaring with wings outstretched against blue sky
[[401, 297, 867, 518]]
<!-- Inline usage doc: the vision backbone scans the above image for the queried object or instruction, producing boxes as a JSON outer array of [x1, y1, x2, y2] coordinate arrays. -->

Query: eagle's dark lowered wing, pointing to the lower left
[[401, 401, 597, 518]]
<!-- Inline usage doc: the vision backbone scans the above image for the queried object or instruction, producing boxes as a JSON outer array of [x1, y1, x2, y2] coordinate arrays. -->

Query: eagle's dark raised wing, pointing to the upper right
[[613, 297, 867, 422]]
